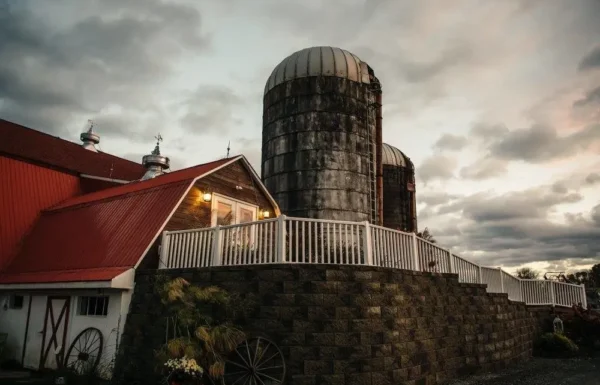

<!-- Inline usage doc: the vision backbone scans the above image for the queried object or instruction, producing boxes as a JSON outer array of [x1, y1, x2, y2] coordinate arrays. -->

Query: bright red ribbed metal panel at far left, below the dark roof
[[0, 156, 80, 271]]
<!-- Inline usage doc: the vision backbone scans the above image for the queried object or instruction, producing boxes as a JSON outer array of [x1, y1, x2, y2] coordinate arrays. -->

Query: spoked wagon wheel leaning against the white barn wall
[[64, 328, 103, 374]]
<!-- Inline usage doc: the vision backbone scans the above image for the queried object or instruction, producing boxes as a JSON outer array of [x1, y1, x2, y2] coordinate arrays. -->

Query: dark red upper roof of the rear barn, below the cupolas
[[0, 119, 146, 180]]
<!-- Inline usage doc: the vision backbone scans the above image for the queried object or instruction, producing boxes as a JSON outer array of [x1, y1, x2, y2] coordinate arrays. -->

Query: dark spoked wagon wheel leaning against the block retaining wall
[[223, 337, 285, 385]]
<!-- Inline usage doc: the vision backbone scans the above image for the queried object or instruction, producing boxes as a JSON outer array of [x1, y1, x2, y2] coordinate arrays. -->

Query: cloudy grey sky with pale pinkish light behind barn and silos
[[0, 0, 600, 272]]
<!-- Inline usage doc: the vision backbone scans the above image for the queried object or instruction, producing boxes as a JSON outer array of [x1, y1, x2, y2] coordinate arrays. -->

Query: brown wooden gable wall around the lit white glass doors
[[165, 160, 275, 231]]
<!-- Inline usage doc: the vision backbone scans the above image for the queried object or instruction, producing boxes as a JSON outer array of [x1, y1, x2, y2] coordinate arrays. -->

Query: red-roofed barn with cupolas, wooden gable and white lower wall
[[0, 121, 279, 375]]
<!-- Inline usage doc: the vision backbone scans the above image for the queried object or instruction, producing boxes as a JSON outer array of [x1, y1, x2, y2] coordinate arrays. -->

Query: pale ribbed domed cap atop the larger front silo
[[265, 47, 370, 94]]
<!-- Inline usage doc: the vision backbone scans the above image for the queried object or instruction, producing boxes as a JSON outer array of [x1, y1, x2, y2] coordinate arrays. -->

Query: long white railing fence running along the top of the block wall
[[160, 215, 587, 307]]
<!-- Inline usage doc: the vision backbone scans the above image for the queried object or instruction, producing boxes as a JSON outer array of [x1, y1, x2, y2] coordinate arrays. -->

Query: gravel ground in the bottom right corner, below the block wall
[[449, 357, 600, 385]]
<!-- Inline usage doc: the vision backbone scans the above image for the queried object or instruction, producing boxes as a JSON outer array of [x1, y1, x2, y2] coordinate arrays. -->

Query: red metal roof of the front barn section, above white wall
[[0, 154, 240, 283]]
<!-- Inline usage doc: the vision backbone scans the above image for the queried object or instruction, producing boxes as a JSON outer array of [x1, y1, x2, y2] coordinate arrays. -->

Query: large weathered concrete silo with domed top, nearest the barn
[[262, 47, 381, 223]]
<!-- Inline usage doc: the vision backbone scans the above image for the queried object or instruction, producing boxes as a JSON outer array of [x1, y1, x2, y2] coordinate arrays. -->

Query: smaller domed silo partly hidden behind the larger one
[[382, 143, 417, 232]]
